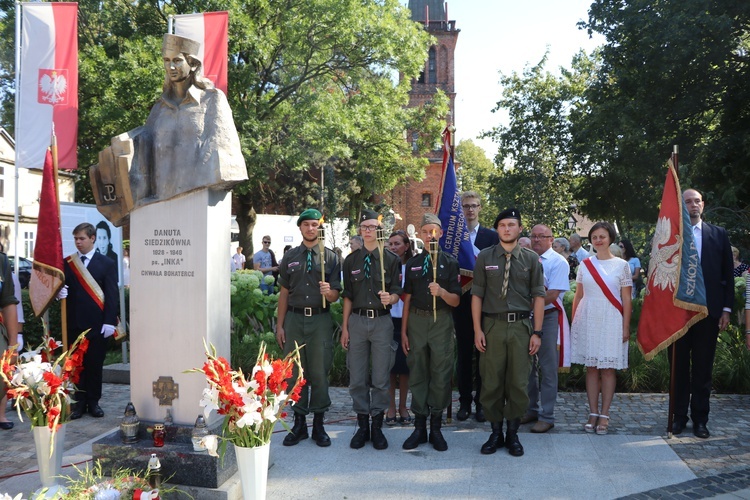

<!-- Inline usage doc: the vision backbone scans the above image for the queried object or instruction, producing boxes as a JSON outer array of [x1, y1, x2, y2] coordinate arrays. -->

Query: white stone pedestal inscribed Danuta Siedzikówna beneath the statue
[[130, 189, 231, 425]]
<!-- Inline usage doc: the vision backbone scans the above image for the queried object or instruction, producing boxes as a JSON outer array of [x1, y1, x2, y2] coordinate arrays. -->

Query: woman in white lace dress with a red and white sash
[[570, 222, 633, 434]]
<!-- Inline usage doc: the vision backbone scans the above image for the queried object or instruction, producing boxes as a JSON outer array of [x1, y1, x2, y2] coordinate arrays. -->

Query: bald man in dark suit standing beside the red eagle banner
[[670, 189, 734, 439]]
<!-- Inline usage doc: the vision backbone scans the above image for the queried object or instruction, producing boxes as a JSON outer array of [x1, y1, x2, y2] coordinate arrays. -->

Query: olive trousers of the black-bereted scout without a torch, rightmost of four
[[479, 316, 532, 422]]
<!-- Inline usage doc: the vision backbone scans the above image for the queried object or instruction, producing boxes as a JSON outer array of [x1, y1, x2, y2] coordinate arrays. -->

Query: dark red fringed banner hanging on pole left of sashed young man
[[29, 149, 65, 317]]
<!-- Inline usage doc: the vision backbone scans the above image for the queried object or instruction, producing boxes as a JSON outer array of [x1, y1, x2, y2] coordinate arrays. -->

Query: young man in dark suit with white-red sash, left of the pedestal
[[63, 222, 119, 420]]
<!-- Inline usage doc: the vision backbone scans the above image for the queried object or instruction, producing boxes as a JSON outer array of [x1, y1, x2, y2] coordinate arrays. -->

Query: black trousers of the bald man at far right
[[669, 316, 719, 424]]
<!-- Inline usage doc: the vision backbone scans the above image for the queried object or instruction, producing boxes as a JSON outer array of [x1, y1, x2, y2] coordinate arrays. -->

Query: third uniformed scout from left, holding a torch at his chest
[[401, 214, 461, 451]]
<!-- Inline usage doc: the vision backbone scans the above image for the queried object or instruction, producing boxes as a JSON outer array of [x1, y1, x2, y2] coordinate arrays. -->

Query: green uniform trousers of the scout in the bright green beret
[[284, 311, 333, 415]]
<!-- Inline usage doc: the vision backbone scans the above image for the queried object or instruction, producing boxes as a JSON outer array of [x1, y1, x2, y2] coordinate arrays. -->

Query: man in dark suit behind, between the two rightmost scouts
[[453, 191, 500, 422]]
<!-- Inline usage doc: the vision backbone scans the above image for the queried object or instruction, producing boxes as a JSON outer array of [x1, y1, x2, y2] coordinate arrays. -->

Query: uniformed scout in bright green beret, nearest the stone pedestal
[[276, 209, 341, 446]]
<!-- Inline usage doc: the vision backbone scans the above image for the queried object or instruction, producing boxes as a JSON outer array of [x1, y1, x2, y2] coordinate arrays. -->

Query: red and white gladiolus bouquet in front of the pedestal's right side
[[189, 342, 306, 456]]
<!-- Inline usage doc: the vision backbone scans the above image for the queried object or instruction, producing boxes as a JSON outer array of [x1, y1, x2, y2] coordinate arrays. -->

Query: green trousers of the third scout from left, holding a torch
[[406, 309, 454, 416]]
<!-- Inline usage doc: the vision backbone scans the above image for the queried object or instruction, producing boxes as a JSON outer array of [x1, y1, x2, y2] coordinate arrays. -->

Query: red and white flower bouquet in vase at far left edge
[[0, 332, 89, 434]]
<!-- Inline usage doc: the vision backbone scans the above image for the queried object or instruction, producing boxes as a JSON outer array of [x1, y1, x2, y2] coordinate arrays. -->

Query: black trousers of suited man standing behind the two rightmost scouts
[[453, 293, 482, 405]]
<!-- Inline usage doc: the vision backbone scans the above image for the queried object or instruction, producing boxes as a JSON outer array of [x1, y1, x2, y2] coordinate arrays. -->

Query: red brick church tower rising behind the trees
[[386, 0, 460, 229]]
